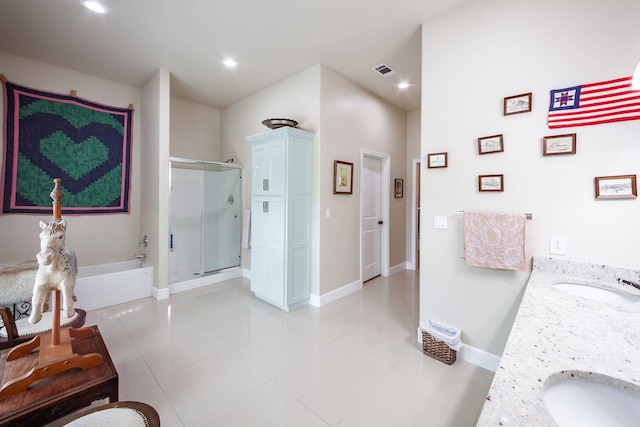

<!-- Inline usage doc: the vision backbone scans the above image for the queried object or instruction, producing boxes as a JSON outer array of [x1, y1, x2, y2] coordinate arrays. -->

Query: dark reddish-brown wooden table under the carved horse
[[0, 326, 118, 426]]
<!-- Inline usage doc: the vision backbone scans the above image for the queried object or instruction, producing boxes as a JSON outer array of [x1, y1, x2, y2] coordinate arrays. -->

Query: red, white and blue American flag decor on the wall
[[548, 76, 640, 129]]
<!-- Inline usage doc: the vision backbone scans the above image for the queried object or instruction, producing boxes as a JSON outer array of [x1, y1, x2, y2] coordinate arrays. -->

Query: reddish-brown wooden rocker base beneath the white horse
[[0, 328, 103, 400]]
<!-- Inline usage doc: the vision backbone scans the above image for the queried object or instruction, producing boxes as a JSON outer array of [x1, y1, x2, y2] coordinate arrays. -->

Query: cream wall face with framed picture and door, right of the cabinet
[[318, 66, 408, 294]]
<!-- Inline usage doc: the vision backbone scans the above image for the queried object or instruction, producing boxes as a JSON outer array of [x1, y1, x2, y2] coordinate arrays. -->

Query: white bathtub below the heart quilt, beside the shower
[[74, 260, 153, 311]]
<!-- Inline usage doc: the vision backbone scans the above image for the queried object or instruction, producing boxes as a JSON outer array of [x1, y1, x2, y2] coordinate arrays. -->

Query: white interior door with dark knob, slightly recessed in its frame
[[361, 156, 383, 282]]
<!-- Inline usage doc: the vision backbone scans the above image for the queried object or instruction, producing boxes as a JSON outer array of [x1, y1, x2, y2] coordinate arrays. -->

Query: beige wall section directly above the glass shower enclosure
[[170, 97, 221, 162]]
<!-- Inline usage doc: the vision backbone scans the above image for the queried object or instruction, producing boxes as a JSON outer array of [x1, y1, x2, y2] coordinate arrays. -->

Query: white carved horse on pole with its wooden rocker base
[[0, 178, 103, 399]]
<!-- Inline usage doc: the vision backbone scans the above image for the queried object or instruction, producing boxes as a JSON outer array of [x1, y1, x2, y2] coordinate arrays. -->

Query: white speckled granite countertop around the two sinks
[[477, 256, 640, 426]]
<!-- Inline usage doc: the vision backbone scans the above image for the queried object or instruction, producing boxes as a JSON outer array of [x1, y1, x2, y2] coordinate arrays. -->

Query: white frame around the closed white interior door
[[358, 148, 391, 283]]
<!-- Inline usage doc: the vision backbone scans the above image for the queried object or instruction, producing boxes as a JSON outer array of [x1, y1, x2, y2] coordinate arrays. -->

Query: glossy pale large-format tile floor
[[56, 271, 493, 427]]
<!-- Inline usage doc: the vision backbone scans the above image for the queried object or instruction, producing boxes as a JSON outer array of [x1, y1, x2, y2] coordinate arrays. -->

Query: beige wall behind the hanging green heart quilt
[[0, 52, 143, 266]]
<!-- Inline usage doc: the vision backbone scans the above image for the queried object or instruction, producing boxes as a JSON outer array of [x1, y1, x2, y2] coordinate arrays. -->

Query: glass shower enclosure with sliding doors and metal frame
[[169, 157, 242, 283]]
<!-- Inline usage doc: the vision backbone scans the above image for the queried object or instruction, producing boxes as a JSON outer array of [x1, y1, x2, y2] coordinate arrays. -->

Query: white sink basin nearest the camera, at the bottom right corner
[[544, 377, 640, 427]]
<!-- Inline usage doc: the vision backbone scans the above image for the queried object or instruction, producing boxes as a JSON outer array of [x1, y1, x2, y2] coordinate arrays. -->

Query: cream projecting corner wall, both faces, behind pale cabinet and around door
[[222, 65, 407, 296]]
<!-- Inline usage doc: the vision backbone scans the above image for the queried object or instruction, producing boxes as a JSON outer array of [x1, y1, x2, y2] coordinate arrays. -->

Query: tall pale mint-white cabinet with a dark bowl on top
[[247, 127, 315, 311]]
